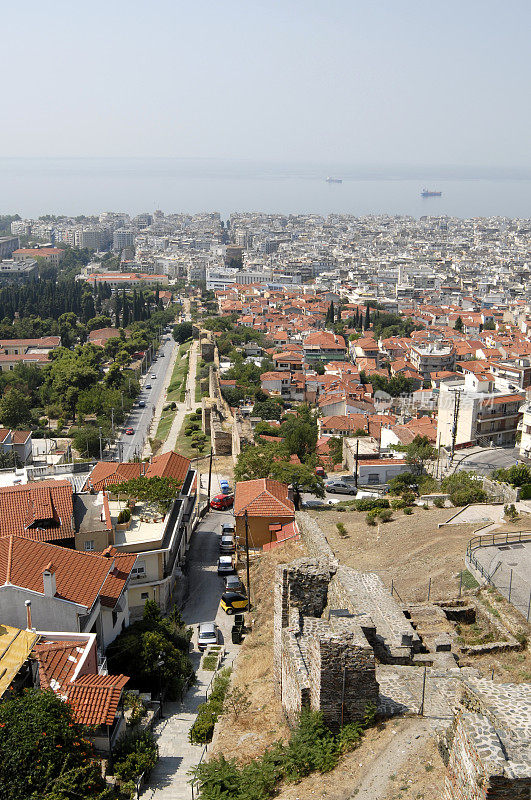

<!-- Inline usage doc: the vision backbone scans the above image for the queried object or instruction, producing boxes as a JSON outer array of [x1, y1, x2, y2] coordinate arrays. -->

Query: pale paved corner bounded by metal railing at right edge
[[466, 531, 531, 622]]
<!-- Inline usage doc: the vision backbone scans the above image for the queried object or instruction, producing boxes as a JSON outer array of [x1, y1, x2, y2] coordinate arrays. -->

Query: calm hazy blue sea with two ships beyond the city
[[0, 158, 531, 219]]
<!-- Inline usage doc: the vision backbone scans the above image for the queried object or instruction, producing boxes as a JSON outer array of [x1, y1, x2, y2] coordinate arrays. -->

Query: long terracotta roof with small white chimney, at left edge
[[0, 536, 136, 608]]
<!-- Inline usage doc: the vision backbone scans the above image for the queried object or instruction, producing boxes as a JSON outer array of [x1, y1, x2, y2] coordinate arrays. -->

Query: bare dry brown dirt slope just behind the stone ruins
[[310, 507, 477, 602]]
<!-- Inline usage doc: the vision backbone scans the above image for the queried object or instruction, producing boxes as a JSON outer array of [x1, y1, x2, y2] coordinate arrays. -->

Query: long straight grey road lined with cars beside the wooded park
[[115, 334, 179, 461]]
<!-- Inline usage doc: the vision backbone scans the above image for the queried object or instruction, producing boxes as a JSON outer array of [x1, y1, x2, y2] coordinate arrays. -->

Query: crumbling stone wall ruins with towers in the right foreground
[[274, 552, 531, 800]]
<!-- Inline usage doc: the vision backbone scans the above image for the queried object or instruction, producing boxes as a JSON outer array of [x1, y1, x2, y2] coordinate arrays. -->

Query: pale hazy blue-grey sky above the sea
[[0, 0, 531, 166]]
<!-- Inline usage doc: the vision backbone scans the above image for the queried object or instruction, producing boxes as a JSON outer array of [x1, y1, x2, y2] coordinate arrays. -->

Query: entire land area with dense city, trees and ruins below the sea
[[0, 211, 531, 800]]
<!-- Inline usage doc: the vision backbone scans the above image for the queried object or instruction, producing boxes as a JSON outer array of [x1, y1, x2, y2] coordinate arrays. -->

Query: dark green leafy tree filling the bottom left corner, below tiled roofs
[[0, 689, 105, 800]]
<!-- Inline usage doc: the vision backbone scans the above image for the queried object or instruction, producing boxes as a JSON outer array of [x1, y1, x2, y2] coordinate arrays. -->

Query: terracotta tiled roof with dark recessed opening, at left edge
[[0, 480, 74, 542]]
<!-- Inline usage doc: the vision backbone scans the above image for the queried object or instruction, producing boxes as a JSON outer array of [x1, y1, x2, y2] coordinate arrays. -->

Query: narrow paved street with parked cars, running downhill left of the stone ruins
[[141, 511, 239, 800]]
